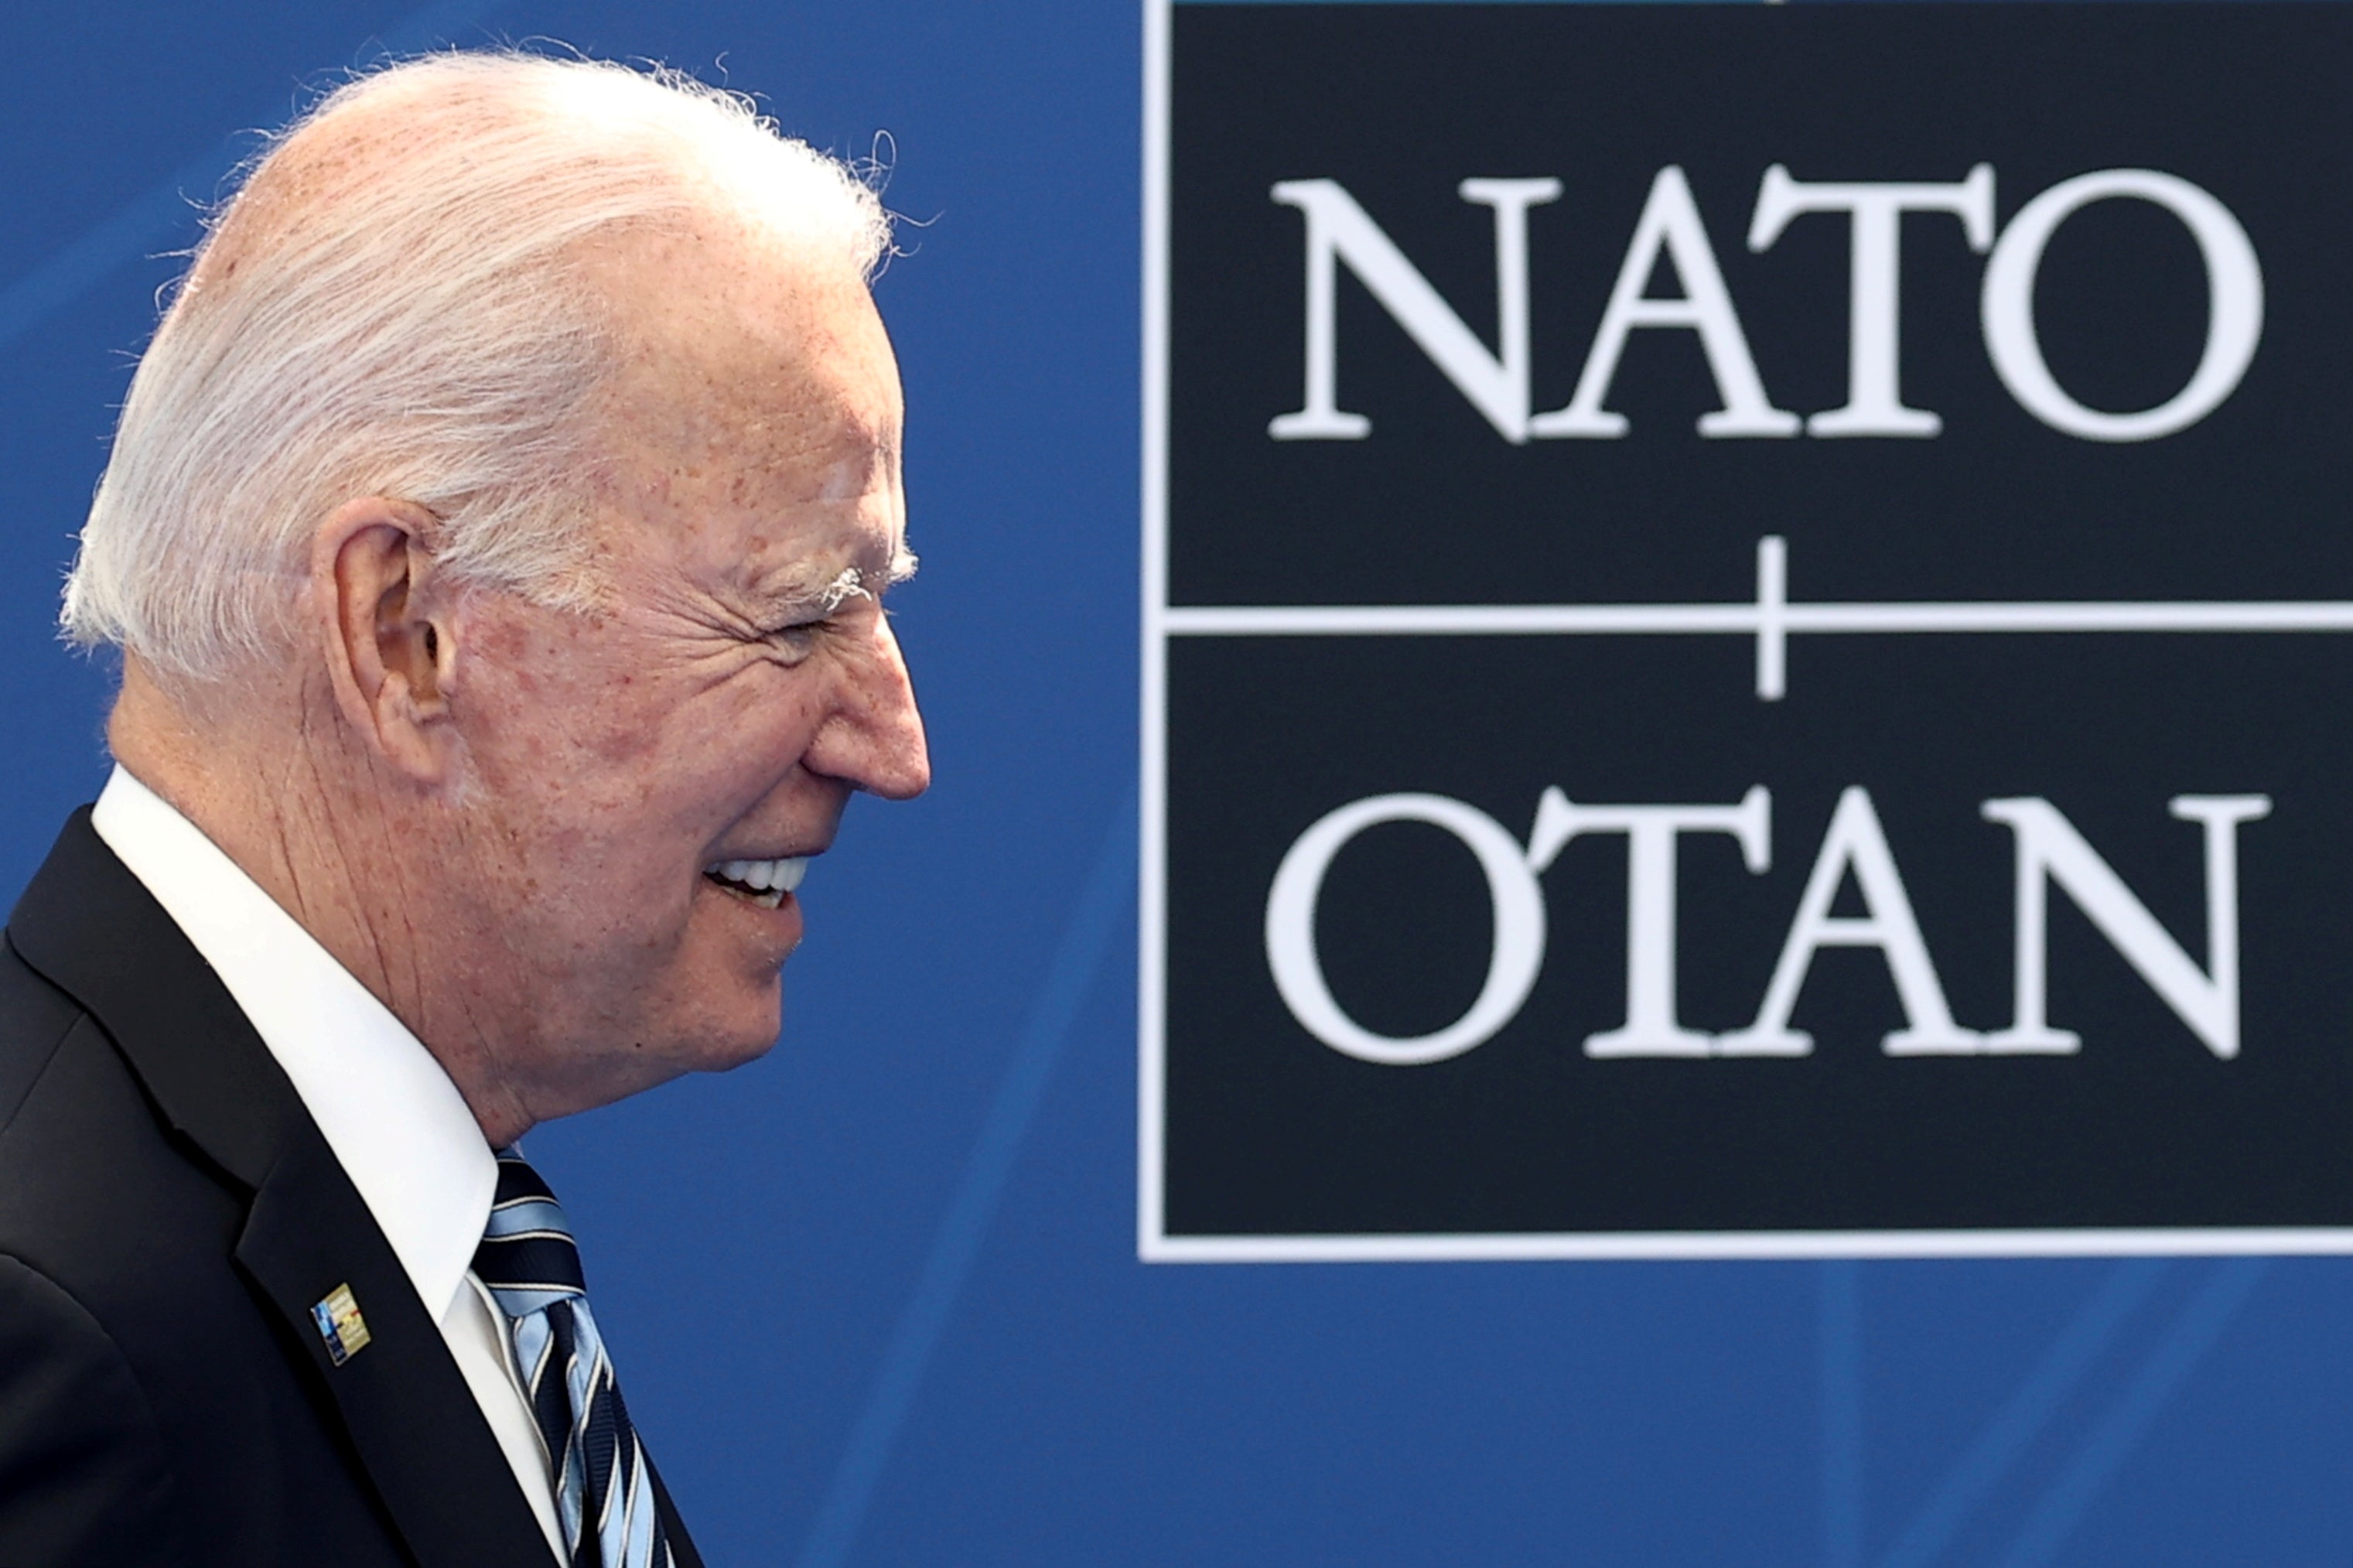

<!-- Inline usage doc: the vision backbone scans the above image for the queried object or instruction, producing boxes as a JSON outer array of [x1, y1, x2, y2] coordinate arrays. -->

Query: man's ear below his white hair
[[311, 497, 459, 784]]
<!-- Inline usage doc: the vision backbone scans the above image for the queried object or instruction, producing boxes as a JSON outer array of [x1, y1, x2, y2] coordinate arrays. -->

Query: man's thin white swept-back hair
[[61, 52, 890, 681]]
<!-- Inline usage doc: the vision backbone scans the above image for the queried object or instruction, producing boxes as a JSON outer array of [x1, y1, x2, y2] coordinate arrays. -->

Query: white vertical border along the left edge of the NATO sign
[[1136, 0, 1172, 1257]]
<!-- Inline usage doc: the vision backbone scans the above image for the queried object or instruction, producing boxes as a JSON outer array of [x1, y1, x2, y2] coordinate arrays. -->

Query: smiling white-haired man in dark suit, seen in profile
[[0, 54, 930, 1568]]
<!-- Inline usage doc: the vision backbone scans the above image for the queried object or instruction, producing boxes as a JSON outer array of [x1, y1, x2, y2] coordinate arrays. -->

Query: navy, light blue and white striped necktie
[[473, 1149, 671, 1568]]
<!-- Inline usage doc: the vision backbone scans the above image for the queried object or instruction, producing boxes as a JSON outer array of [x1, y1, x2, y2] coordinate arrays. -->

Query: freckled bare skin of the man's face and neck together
[[113, 233, 930, 1142]]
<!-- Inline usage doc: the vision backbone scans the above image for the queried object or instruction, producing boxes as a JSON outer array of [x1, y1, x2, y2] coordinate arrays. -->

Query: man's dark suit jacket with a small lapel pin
[[0, 810, 698, 1568]]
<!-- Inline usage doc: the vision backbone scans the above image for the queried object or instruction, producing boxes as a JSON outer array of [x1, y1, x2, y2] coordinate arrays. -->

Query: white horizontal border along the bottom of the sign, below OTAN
[[1139, 1227, 2353, 1264]]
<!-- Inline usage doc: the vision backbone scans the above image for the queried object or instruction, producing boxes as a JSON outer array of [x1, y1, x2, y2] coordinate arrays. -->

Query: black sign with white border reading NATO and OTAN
[[1141, 5, 2353, 1259]]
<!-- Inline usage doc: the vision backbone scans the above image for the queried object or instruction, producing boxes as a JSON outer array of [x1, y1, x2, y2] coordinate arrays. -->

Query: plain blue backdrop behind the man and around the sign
[[0, 0, 2353, 1568]]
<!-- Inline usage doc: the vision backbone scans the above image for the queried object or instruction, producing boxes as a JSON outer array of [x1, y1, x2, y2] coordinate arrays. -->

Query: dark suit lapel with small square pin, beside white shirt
[[7, 810, 548, 1568]]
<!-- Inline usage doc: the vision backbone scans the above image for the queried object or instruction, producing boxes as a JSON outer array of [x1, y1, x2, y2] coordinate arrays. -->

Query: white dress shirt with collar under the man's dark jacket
[[92, 767, 565, 1563]]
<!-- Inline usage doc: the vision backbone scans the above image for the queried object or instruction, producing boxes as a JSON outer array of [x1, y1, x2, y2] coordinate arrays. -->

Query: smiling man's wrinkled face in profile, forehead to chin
[[444, 240, 930, 1114]]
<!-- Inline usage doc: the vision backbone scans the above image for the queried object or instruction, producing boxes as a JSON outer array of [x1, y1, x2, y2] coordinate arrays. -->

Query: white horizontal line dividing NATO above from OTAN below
[[1160, 600, 2353, 638]]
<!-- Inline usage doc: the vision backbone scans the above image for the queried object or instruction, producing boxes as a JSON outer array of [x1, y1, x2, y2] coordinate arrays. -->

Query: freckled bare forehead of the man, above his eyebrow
[[596, 235, 901, 577]]
